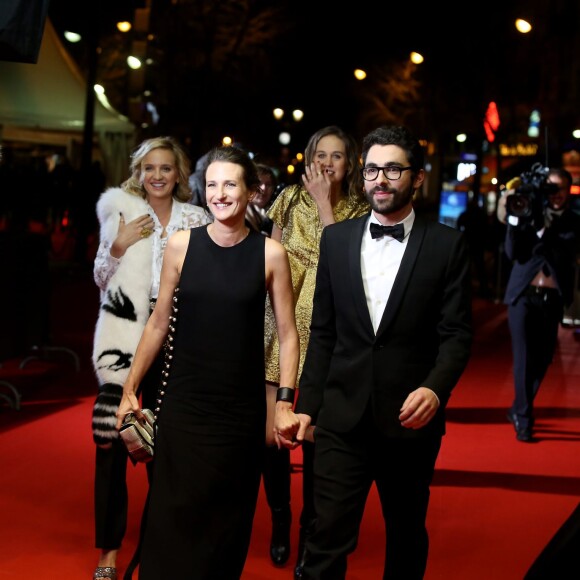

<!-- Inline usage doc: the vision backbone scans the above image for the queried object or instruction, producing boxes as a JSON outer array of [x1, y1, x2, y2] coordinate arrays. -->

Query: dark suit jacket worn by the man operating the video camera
[[504, 209, 580, 306]]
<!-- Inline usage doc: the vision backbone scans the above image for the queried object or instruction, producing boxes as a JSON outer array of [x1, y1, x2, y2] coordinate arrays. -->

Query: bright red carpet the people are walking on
[[0, 271, 580, 580]]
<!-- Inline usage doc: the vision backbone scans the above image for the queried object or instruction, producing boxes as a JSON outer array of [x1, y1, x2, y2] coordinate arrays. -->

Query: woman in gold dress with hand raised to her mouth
[[265, 126, 370, 578]]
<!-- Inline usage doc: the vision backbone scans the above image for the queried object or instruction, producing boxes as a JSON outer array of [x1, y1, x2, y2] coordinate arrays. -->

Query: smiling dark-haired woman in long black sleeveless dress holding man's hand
[[117, 147, 299, 580]]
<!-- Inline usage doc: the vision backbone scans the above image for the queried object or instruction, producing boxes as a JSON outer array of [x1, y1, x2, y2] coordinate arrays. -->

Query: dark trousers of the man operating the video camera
[[508, 287, 563, 429]]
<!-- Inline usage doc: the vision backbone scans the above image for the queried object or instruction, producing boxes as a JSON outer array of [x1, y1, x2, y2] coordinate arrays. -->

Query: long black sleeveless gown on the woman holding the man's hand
[[139, 226, 266, 580]]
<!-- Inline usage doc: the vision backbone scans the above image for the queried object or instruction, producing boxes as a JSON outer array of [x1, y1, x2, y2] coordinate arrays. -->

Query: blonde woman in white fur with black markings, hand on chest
[[92, 137, 211, 580]]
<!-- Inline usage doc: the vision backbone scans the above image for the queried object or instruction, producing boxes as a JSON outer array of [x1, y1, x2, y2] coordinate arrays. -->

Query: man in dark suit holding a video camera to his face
[[497, 168, 580, 442]]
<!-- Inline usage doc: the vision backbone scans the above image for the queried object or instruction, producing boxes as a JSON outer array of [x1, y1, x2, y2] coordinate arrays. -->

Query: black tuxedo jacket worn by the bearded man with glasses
[[296, 215, 472, 437]]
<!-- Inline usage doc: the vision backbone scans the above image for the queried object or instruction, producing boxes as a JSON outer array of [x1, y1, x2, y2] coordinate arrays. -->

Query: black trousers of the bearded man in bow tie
[[304, 413, 441, 580]]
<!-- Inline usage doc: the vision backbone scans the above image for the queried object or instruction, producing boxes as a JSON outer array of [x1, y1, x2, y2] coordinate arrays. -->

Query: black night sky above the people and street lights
[[34, 0, 580, 161]]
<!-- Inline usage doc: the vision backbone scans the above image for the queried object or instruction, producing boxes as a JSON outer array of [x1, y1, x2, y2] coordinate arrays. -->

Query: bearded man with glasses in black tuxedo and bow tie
[[296, 126, 472, 580]]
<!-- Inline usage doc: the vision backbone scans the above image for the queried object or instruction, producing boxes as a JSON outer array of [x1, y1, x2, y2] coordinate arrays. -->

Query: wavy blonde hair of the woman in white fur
[[121, 137, 192, 202]]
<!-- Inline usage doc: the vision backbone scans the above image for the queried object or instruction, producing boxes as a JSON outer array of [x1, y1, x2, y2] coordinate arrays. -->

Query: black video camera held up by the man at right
[[506, 163, 558, 229]]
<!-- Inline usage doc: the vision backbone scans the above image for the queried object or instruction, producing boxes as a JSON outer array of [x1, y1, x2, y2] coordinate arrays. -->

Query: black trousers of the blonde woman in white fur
[[94, 350, 164, 550]]
